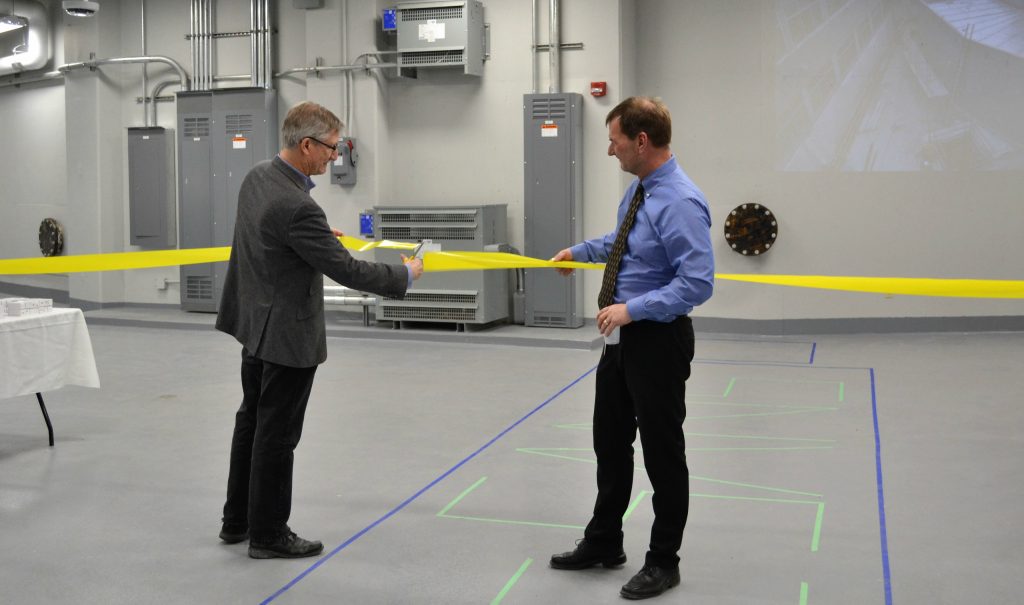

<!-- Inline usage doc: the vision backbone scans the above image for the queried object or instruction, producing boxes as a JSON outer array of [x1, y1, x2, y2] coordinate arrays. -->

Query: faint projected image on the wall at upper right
[[773, 0, 1024, 172]]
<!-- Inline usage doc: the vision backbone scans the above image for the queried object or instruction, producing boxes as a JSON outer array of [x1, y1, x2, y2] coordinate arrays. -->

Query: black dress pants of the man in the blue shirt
[[584, 316, 693, 568]]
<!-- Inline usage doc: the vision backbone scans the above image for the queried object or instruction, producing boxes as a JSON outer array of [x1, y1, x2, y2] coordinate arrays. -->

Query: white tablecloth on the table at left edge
[[0, 309, 99, 399]]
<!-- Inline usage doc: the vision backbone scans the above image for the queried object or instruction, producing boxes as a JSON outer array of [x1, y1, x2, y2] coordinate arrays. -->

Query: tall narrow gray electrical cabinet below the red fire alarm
[[523, 92, 583, 328]]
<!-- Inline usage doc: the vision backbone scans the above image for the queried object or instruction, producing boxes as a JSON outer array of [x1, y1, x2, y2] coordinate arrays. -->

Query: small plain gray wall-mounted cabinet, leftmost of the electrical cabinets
[[128, 127, 177, 248]]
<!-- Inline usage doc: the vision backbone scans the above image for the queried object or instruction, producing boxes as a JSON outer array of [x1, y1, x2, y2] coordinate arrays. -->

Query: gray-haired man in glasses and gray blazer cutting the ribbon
[[217, 101, 423, 559]]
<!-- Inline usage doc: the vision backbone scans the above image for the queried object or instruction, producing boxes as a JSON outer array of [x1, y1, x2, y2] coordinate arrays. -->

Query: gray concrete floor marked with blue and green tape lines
[[0, 311, 1024, 605]]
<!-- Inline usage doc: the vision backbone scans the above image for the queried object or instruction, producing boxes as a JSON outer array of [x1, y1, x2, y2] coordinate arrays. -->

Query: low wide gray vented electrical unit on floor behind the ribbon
[[372, 204, 510, 327]]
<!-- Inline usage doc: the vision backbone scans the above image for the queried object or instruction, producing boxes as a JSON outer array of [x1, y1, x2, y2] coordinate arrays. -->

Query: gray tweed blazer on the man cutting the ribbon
[[216, 157, 409, 368]]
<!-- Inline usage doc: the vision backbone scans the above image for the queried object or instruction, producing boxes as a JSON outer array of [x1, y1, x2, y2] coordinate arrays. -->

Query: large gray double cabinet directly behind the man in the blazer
[[177, 88, 278, 312]]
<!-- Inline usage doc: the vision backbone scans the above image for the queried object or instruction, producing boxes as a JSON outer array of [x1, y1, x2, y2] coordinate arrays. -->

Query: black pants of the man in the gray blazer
[[223, 348, 316, 542]]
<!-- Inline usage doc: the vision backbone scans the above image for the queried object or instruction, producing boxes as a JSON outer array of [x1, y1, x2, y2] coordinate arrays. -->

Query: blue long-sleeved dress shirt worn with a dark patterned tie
[[570, 155, 715, 321]]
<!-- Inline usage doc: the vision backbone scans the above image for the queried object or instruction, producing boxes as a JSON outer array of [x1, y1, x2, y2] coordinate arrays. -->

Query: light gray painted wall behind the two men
[[0, 0, 1024, 320]]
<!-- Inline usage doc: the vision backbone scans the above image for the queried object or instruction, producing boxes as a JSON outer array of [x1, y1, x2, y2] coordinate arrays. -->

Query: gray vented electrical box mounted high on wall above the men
[[395, 0, 485, 76]]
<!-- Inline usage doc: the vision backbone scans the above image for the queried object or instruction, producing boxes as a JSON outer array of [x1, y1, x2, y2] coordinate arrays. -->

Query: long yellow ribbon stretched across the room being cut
[[0, 235, 1024, 299]]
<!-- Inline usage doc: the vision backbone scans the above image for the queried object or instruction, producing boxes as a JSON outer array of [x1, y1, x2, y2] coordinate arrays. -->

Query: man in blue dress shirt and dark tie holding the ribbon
[[551, 97, 715, 599]]
